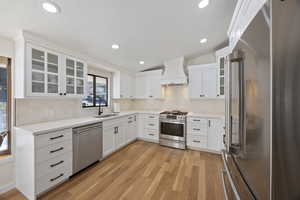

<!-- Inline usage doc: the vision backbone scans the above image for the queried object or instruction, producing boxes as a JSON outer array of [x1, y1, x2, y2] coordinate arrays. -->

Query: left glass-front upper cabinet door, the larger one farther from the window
[[27, 46, 60, 96]]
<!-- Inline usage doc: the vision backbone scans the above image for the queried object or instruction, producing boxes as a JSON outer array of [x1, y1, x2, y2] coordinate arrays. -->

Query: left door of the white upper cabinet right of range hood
[[189, 68, 203, 99]]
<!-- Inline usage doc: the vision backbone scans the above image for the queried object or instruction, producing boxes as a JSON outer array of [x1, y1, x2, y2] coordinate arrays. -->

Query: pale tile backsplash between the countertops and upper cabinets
[[15, 86, 225, 126]]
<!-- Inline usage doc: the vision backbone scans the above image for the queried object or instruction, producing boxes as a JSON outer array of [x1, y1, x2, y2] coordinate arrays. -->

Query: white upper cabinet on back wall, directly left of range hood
[[135, 70, 164, 99]]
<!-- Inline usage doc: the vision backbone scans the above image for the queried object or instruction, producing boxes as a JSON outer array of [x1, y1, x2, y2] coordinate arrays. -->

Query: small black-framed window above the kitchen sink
[[82, 74, 109, 108]]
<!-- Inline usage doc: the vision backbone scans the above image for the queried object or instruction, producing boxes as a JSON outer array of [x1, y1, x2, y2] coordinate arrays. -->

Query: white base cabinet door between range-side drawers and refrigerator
[[207, 119, 222, 151]]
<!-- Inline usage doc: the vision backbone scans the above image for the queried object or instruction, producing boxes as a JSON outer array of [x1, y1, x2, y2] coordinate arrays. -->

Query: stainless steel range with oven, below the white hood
[[159, 111, 187, 149]]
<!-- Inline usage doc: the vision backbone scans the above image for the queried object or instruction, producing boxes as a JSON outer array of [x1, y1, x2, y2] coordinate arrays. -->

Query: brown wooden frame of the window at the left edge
[[0, 56, 12, 155]]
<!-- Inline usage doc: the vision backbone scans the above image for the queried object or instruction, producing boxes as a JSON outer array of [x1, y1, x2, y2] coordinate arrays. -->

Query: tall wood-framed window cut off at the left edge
[[0, 56, 11, 155]]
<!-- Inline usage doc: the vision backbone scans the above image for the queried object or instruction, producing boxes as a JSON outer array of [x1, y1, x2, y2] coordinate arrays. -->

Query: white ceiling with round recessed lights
[[0, 0, 236, 71]]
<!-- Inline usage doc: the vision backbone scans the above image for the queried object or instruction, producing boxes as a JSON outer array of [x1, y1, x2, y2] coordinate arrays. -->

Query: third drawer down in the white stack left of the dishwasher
[[36, 152, 72, 179]]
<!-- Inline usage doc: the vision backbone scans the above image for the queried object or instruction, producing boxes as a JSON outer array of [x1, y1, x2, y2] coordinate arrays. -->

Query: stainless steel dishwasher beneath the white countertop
[[73, 123, 102, 174]]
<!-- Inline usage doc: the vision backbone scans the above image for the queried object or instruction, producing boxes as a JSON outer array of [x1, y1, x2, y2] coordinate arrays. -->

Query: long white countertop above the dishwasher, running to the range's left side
[[15, 111, 160, 135]]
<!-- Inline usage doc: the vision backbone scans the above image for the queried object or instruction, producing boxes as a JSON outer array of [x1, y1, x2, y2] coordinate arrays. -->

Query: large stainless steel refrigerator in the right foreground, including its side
[[222, 0, 300, 200]]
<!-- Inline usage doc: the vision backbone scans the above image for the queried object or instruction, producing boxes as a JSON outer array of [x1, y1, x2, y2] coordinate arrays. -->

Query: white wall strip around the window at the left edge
[[0, 37, 15, 193]]
